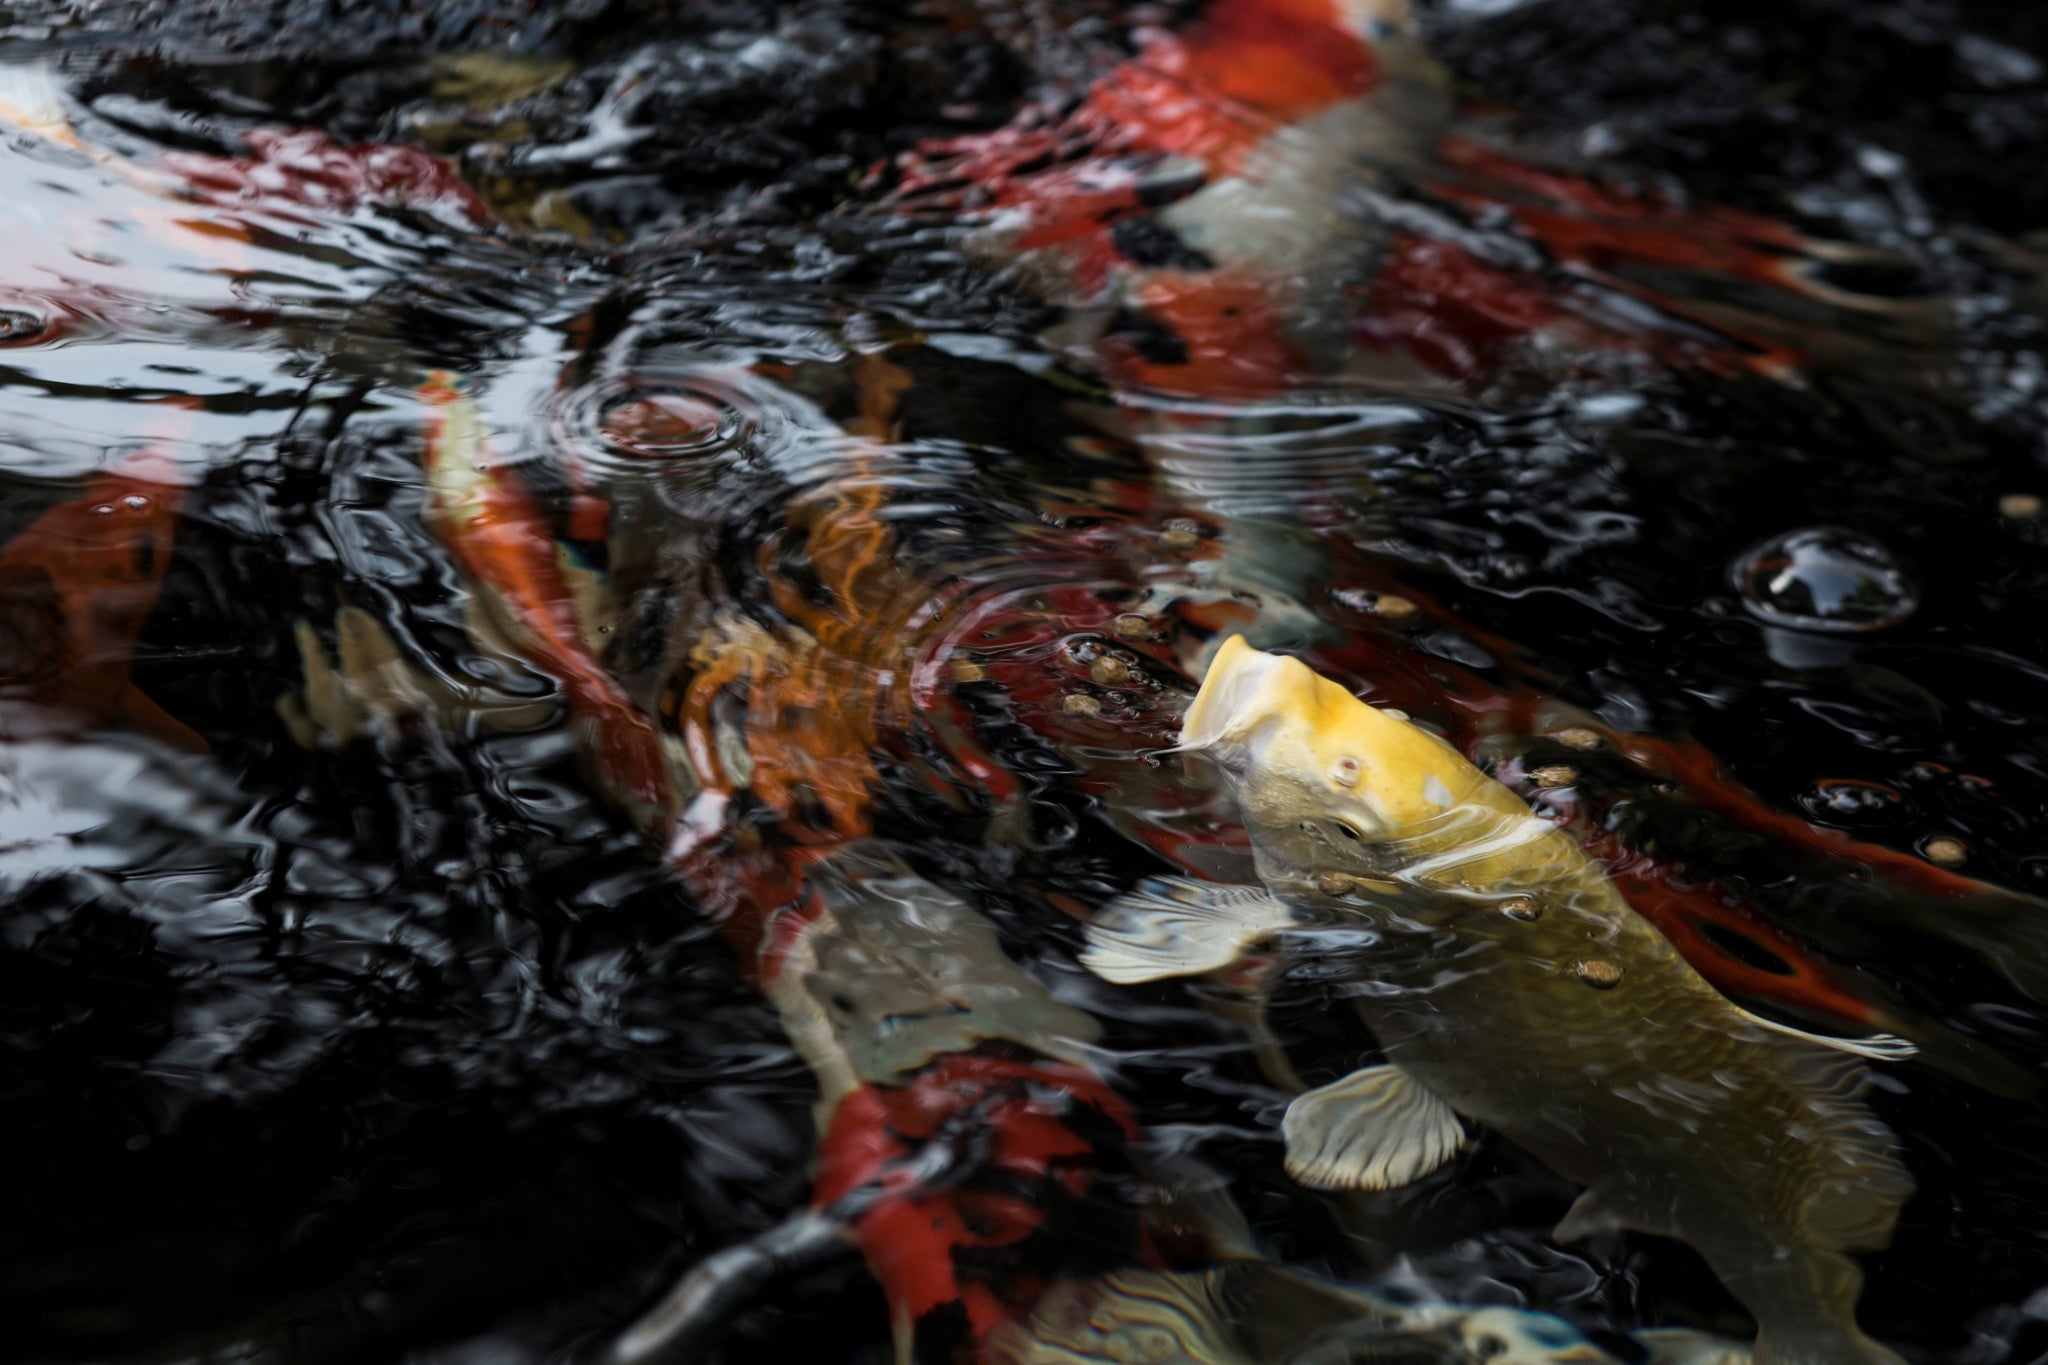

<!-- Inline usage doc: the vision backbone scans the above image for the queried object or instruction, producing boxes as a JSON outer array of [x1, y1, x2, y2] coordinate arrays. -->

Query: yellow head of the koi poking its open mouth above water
[[1180, 636, 1495, 876]]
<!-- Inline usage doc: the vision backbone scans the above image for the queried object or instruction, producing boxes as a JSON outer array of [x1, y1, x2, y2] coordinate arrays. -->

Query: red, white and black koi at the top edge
[[897, 0, 1440, 395]]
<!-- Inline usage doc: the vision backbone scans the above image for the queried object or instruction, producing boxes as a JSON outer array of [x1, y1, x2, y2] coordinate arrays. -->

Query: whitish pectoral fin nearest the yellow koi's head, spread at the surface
[[1081, 876, 1294, 986]]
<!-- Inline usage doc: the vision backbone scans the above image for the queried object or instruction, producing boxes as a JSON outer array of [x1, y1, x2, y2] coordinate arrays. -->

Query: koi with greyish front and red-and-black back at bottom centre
[[762, 843, 1163, 1361]]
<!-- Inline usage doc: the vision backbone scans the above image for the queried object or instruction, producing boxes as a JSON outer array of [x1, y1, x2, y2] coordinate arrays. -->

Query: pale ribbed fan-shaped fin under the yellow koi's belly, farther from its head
[[1280, 1064, 1464, 1189]]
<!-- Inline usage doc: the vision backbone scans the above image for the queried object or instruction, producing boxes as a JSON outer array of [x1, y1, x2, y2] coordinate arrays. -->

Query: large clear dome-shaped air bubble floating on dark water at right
[[1731, 526, 1919, 634]]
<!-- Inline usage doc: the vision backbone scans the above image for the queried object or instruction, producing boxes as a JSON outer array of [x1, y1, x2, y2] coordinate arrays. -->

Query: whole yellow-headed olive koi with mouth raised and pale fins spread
[[1090, 641, 1913, 1365]]
